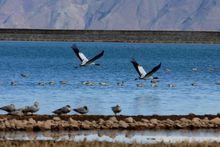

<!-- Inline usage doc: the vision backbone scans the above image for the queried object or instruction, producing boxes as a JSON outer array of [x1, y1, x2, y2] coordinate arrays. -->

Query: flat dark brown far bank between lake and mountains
[[0, 28, 220, 44]]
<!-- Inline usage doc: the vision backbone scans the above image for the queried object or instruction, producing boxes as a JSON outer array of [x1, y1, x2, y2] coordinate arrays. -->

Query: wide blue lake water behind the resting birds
[[0, 42, 220, 115]]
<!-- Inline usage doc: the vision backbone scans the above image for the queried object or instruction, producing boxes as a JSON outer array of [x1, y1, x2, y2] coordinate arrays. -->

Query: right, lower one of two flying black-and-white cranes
[[131, 59, 161, 80]]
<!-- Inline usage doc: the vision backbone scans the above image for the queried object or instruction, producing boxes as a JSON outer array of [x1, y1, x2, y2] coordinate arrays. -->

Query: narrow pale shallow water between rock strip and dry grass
[[0, 130, 220, 143]]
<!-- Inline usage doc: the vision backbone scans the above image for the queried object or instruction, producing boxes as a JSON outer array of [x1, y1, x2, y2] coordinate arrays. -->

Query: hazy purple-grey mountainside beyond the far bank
[[0, 0, 220, 31]]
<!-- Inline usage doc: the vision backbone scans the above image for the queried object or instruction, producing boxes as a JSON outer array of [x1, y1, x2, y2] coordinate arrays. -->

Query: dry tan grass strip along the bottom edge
[[0, 141, 220, 147]]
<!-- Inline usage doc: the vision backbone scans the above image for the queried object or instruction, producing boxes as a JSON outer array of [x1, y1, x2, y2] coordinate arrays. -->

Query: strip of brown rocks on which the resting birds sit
[[0, 114, 220, 131]]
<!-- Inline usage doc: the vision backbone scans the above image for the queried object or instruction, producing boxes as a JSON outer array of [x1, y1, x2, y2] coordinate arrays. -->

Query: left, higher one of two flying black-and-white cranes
[[71, 44, 104, 66]]
